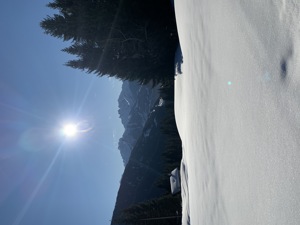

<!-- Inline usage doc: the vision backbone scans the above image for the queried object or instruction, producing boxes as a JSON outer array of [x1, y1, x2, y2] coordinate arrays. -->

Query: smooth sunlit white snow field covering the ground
[[175, 0, 300, 225]]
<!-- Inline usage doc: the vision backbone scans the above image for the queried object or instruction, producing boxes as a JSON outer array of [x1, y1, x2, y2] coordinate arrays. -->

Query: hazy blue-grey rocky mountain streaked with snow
[[118, 81, 159, 165]]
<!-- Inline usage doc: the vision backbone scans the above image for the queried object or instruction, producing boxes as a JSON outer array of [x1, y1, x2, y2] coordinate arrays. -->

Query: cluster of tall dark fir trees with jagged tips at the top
[[40, 0, 178, 84]]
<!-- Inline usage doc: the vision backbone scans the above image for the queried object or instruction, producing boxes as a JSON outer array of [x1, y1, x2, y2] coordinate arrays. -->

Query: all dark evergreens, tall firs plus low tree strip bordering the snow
[[40, 0, 181, 224]]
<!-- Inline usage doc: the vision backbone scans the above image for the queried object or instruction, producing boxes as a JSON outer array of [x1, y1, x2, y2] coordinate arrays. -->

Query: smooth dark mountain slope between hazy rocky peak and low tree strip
[[112, 99, 166, 224]]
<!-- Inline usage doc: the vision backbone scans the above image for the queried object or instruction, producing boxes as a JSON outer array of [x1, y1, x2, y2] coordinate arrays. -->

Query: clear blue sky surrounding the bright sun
[[0, 0, 124, 225]]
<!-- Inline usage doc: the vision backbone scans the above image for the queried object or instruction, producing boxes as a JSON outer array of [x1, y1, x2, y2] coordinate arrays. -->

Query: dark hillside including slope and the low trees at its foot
[[111, 82, 182, 225]]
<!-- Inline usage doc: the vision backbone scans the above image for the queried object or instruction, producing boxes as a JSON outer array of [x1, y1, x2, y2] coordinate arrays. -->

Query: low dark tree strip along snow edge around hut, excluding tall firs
[[111, 82, 182, 225]]
